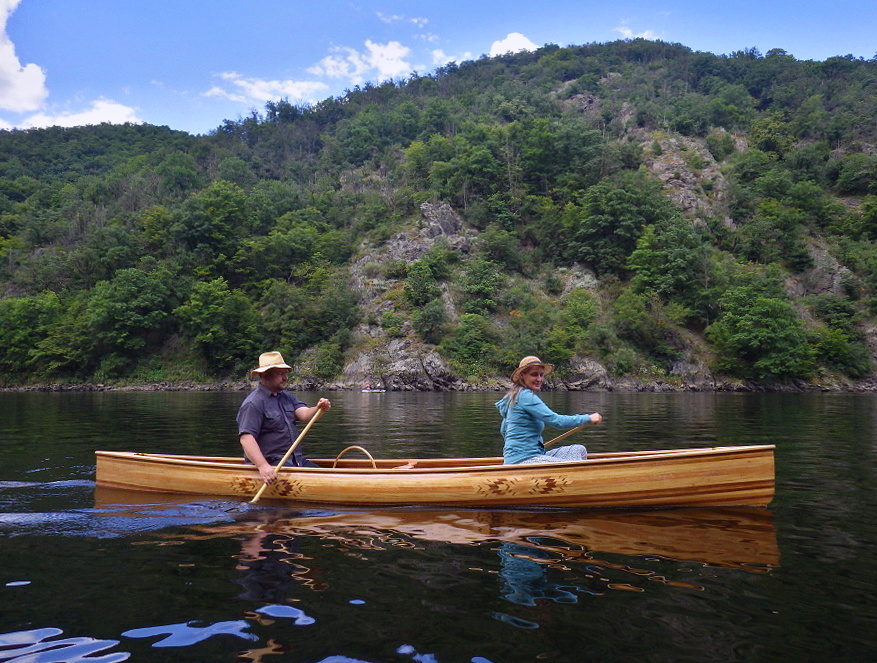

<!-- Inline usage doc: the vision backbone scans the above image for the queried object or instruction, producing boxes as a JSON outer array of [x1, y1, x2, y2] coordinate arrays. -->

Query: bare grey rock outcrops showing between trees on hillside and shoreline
[[296, 130, 877, 391]]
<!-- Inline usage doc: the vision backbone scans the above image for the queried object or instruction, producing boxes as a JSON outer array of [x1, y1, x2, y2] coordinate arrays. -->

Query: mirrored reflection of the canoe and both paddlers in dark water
[[190, 508, 779, 629]]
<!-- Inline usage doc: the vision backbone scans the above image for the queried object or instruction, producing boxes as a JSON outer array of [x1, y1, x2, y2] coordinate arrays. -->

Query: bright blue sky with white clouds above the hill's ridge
[[0, 0, 877, 134]]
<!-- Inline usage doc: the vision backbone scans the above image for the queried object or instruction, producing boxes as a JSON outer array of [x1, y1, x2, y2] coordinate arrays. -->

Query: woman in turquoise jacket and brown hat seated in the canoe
[[496, 357, 603, 465]]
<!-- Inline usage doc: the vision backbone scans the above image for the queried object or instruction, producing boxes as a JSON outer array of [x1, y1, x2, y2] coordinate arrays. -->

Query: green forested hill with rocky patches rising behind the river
[[0, 40, 877, 388]]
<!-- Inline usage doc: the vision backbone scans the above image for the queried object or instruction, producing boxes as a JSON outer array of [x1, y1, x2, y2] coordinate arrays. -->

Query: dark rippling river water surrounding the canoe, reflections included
[[0, 392, 877, 663]]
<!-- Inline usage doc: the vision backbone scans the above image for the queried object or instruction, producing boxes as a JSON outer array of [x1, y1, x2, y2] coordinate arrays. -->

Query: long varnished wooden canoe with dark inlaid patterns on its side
[[96, 445, 774, 508]]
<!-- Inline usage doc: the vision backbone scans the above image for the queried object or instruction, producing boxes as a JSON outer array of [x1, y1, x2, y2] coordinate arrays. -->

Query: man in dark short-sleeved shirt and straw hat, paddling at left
[[237, 352, 332, 484]]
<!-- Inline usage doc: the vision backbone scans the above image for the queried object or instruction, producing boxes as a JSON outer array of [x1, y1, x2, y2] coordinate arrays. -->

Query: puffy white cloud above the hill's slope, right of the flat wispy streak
[[308, 40, 412, 85]]
